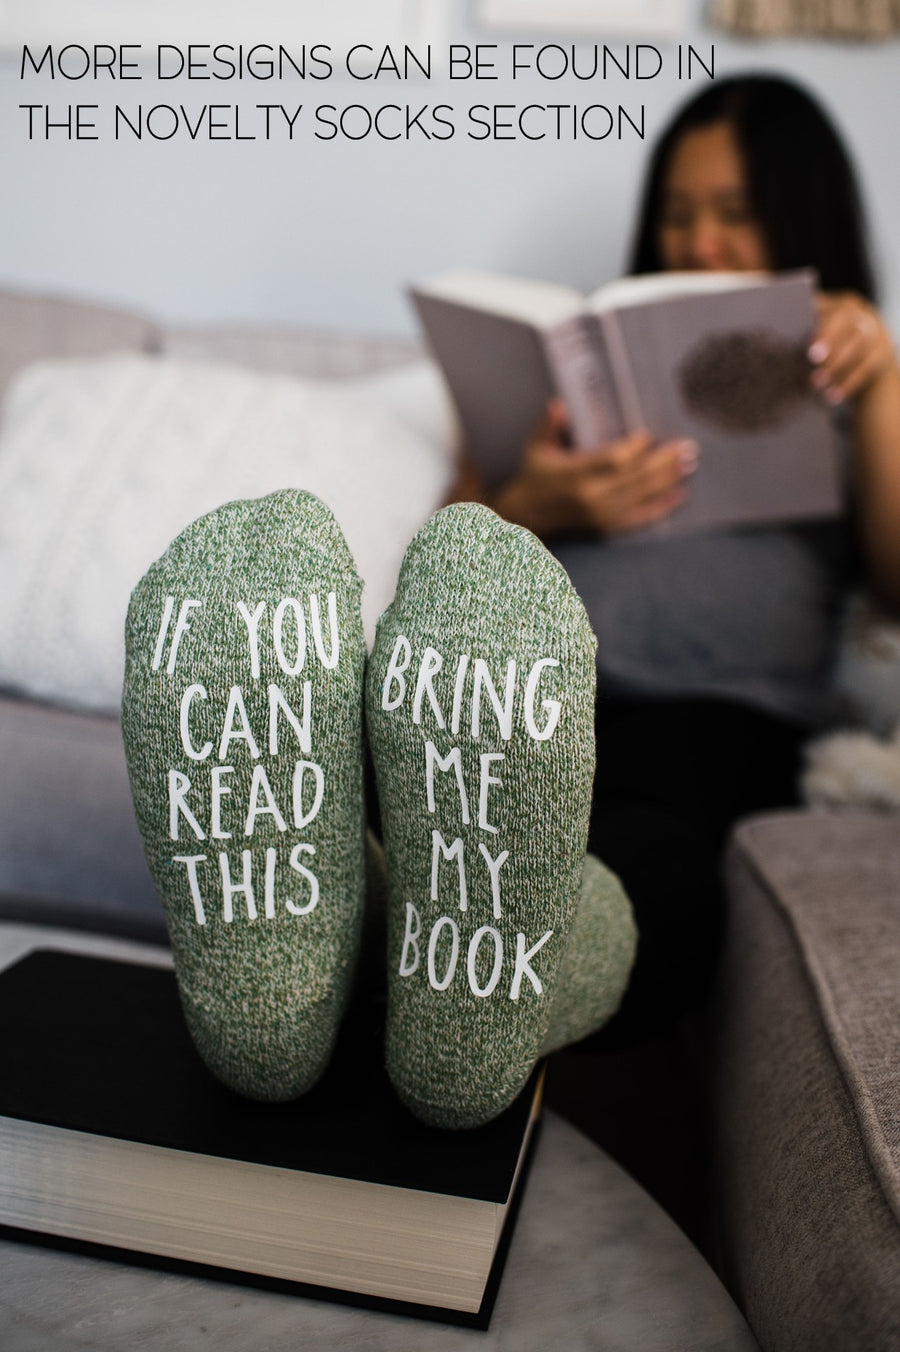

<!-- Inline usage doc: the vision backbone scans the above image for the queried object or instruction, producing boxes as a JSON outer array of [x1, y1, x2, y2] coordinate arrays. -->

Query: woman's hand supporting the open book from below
[[491, 399, 697, 538]]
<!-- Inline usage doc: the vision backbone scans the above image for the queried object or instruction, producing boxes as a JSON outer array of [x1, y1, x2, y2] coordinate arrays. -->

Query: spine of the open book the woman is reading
[[543, 315, 626, 448]]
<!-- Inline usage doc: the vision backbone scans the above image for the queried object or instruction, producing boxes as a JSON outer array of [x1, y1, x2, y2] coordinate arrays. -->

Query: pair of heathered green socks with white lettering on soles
[[122, 489, 635, 1128]]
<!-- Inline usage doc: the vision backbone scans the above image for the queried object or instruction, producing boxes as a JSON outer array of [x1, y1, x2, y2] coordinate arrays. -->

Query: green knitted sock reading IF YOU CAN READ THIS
[[122, 491, 365, 1102]]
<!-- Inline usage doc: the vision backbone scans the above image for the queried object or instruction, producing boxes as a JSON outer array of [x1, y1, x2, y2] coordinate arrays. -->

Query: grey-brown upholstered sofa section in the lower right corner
[[718, 813, 900, 1352]]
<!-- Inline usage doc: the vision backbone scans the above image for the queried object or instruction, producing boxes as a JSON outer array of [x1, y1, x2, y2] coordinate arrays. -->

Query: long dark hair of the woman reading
[[628, 74, 876, 300]]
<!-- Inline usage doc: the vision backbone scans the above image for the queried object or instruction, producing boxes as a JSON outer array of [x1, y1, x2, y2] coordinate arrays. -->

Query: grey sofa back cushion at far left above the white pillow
[[0, 289, 159, 397]]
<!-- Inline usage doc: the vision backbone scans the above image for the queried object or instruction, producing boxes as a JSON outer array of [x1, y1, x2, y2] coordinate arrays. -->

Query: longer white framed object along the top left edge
[[0, 0, 447, 51]]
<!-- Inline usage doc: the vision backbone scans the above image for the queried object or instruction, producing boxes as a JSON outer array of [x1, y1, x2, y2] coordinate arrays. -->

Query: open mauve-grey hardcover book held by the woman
[[412, 272, 841, 533]]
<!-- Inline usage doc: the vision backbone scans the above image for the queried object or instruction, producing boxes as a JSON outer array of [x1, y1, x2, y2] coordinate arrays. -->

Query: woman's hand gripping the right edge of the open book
[[809, 291, 896, 404]]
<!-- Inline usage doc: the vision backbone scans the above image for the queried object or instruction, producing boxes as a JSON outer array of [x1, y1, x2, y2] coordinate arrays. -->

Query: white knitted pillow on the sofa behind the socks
[[0, 356, 454, 710]]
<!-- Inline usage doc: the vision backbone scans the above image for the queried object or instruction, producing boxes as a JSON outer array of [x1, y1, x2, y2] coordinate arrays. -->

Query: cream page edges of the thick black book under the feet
[[0, 1118, 497, 1313]]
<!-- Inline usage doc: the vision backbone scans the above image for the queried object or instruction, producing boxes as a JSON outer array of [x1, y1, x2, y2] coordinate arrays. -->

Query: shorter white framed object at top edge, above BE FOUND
[[476, 0, 688, 38]]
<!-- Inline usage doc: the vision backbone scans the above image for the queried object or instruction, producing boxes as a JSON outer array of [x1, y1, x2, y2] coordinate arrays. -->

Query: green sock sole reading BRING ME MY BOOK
[[366, 503, 595, 1128]]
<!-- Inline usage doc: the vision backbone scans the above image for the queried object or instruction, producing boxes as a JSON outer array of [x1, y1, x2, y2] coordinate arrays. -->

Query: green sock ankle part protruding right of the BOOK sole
[[541, 854, 638, 1056]]
